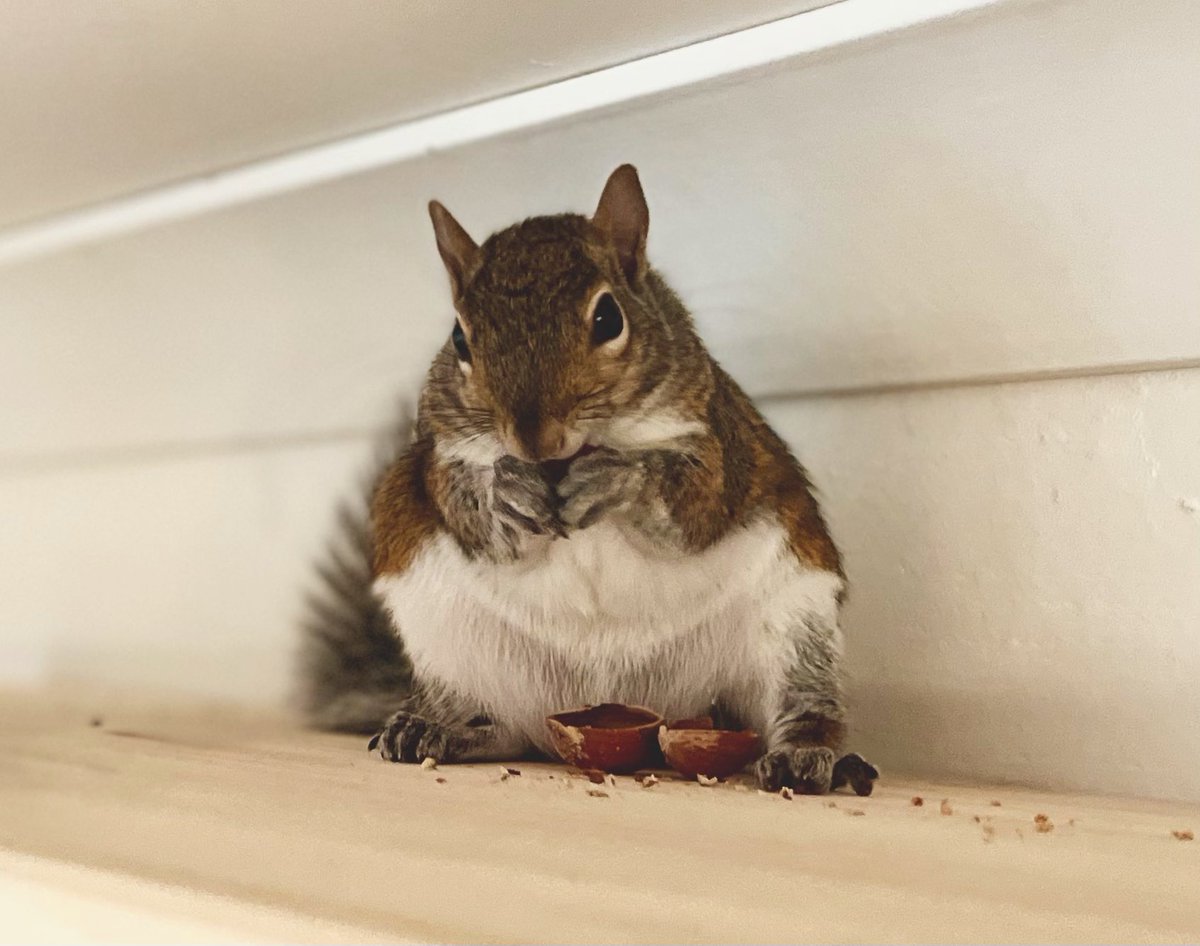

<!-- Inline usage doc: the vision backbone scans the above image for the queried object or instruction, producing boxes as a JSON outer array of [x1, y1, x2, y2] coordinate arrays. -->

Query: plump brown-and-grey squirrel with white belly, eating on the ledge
[[300, 164, 878, 794]]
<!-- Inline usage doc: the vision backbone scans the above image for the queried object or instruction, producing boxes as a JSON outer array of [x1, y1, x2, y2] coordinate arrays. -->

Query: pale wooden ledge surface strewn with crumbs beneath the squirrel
[[0, 691, 1200, 942]]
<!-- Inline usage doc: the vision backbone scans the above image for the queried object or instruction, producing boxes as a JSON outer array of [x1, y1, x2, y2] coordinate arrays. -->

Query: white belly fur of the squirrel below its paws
[[376, 521, 842, 749]]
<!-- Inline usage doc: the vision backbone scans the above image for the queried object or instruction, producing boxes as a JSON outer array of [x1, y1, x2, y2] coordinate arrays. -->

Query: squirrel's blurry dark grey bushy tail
[[298, 418, 413, 734]]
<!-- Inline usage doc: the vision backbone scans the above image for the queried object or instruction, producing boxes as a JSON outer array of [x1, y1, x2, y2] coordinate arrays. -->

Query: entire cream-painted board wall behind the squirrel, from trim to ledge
[[0, 0, 1200, 800]]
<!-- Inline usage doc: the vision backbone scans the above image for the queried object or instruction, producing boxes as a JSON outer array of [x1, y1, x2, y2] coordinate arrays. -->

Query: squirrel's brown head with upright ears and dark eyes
[[430, 164, 698, 461]]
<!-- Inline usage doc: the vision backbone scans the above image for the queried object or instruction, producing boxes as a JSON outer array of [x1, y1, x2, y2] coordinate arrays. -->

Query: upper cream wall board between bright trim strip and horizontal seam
[[0, 0, 1200, 462]]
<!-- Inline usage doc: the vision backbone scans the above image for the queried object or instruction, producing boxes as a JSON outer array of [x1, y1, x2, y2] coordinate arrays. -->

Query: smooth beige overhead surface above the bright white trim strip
[[0, 0, 830, 227]]
